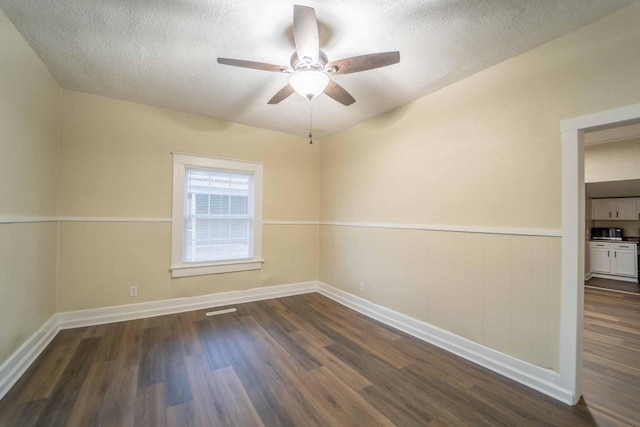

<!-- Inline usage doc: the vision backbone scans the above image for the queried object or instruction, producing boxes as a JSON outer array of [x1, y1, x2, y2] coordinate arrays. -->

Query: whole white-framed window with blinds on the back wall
[[171, 153, 263, 277]]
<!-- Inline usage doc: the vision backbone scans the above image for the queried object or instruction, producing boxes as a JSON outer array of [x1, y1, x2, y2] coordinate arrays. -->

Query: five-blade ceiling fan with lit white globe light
[[218, 5, 400, 105]]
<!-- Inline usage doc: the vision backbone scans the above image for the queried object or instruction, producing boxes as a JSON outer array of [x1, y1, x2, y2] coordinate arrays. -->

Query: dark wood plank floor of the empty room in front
[[0, 294, 638, 427]]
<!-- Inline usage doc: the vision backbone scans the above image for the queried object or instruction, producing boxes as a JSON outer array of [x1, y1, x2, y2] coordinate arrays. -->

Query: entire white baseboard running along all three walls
[[0, 281, 573, 404]]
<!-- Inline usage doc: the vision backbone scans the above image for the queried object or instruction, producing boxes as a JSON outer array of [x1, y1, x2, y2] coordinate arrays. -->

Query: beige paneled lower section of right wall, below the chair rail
[[320, 226, 560, 369]]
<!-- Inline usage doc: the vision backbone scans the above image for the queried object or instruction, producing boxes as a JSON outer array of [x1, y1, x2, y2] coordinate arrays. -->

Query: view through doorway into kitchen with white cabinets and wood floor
[[583, 131, 640, 425]]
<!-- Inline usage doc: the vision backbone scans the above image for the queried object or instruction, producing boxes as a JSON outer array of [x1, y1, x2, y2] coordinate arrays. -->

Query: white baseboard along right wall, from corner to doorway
[[318, 282, 573, 405]]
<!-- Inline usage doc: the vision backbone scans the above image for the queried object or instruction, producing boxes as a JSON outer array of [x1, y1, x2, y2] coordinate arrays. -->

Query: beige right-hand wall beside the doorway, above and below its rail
[[320, 3, 640, 372]]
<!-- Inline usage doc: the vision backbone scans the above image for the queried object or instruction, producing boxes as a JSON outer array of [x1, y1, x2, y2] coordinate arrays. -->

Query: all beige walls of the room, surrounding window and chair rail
[[0, 0, 640, 382]]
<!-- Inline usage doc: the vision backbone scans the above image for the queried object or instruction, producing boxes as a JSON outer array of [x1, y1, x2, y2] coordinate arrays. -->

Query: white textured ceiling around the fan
[[0, 0, 633, 136]]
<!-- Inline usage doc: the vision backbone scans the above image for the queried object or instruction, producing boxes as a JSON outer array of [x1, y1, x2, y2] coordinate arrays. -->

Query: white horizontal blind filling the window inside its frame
[[183, 167, 253, 263]]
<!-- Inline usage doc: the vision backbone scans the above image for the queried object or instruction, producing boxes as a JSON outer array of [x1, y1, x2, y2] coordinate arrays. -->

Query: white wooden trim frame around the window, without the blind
[[170, 153, 264, 278]]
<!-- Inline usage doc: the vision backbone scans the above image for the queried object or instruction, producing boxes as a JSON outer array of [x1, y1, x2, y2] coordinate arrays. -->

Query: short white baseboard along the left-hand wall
[[0, 314, 60, 399]]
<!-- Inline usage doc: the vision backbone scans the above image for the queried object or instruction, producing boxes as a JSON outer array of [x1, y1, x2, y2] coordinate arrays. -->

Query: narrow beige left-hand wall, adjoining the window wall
[[0, 12, 60, 363]]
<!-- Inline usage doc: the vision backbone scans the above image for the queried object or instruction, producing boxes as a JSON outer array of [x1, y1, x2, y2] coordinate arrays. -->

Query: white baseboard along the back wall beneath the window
[[57, 281, 318, 329]]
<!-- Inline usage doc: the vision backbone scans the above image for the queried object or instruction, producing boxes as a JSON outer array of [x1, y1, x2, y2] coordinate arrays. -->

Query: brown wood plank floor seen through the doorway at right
[[582, 288, 640, 426]]
